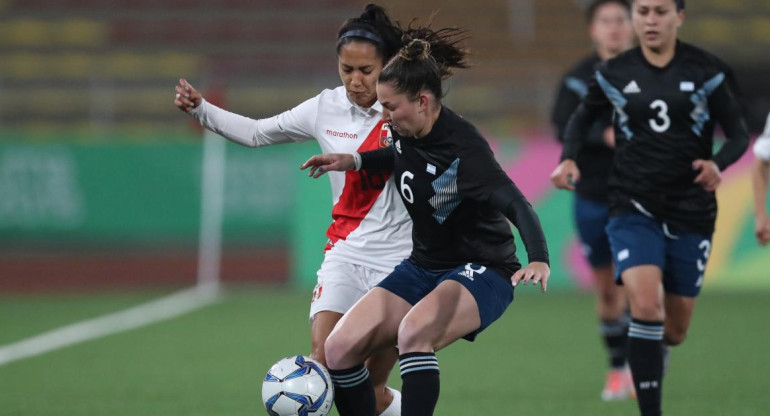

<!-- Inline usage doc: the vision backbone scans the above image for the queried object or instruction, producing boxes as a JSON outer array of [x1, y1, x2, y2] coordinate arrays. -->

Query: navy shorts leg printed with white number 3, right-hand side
[[663, 233, 711, 297]]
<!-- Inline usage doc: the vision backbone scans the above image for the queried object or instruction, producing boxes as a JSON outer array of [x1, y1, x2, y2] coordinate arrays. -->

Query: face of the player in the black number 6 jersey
[[377, 83, 429, 137]]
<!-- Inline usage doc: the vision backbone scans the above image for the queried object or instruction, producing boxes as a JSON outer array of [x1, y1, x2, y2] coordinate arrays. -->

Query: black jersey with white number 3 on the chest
[[562, 42, 748, 234]]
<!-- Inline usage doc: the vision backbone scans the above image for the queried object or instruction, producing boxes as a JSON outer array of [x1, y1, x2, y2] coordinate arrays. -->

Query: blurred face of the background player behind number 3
[[591, 3, 634, 55]]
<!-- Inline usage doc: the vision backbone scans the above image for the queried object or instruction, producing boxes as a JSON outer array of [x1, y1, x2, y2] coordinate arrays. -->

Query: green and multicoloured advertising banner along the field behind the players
[[0, 136, 770, 289]]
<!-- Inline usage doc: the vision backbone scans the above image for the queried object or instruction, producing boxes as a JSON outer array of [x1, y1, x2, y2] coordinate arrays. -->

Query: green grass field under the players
[[0, 288, 770, 416]]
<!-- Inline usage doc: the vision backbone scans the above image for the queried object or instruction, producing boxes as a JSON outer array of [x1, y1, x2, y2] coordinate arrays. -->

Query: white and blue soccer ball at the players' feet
[[262, 355, 334, 416]]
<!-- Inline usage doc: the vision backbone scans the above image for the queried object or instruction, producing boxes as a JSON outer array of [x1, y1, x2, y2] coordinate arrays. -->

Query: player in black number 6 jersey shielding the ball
[[302, 29, 550, 416]]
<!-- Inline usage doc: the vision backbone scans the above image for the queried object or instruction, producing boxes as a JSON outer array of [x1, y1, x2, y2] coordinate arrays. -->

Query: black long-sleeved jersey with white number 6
[[361, 107, 548, 274]]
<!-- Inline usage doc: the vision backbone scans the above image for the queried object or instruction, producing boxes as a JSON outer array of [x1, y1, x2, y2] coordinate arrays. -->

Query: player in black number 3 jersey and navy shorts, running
[[553, 0, 748, 416]]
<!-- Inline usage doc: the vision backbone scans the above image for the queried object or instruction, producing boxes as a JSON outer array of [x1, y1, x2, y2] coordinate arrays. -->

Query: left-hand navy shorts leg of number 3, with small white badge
[[607, 214, 666, 283]]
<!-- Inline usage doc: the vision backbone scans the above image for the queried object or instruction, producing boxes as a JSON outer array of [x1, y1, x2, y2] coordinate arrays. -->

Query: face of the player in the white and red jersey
[[337, 41, 382, 108]]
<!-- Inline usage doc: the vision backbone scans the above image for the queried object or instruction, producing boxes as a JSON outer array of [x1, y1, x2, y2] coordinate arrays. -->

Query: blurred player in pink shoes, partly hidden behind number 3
[[551, 0, 634, 400]]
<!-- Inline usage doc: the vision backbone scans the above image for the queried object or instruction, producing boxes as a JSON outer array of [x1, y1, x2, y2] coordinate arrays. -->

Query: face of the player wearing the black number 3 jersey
[[631, 0, 684, 50]]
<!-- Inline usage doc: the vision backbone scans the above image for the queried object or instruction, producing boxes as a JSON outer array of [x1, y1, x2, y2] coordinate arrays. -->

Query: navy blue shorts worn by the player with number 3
[[607, 214, 711, 297]]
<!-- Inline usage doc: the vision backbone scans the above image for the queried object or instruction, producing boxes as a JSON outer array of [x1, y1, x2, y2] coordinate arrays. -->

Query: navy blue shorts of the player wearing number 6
[[377, 259, 513, 341]]
